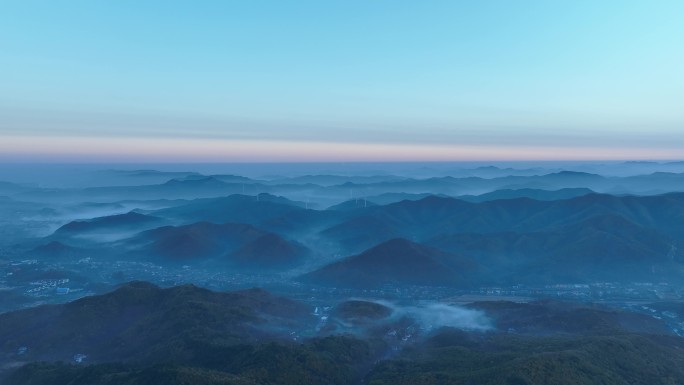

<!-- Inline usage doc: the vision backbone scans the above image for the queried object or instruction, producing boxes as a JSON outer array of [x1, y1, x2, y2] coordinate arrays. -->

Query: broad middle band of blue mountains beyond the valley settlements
[[32, 188, 684, 286]]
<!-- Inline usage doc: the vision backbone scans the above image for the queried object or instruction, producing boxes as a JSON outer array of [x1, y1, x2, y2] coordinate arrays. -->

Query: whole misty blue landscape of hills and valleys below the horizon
[[0, 162, 684, 385]]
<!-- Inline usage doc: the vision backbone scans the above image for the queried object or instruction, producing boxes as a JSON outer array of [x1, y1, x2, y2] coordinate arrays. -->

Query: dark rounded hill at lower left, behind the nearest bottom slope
[[0, 283, 312, 362]]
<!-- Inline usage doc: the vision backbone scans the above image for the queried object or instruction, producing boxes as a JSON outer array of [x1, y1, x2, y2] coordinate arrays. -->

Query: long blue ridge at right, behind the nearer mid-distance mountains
[[320, 193, 684, 250]]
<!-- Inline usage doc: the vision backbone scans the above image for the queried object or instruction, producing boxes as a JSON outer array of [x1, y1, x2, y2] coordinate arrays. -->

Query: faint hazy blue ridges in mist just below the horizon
[[8, 163, 684, 208]]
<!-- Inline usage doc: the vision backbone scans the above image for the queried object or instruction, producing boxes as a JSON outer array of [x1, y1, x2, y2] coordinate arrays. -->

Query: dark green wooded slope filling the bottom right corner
[[366, 329, 684, 385]]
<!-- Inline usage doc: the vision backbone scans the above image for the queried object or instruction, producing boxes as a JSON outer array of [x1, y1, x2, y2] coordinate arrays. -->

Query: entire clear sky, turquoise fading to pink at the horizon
[[0, 0, 684, 162]]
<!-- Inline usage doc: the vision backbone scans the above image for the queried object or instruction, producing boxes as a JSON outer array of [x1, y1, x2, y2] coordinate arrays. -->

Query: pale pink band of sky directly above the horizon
[[0, 136, 684, 162]]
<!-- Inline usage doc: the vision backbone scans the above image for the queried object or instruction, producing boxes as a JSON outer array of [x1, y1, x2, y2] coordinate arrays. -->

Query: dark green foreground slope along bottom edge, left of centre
[[7, 336, 374, 385]]
